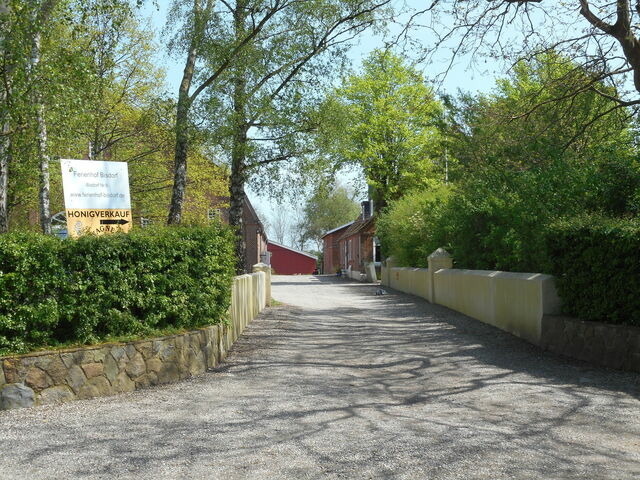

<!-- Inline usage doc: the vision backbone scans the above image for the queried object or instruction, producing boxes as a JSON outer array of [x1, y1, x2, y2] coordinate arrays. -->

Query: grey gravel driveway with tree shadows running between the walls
[[0, 276, 640, 480]]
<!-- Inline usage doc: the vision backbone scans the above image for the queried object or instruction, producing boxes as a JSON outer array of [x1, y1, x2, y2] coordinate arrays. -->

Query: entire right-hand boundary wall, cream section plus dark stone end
[[382, 249, 640, 372]]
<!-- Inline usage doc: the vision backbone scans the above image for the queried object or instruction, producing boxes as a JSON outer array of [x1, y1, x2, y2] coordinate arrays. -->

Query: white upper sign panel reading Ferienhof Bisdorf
[[60, 160, 131, 210]]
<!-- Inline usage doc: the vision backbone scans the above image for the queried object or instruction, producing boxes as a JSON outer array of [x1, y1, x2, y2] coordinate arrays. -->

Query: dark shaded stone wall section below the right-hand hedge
[[540, 315, 640, 372]]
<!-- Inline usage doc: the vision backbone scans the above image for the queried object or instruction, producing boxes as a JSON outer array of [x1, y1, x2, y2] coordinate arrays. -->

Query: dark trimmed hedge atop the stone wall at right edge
[[545, 216, 640, 326]]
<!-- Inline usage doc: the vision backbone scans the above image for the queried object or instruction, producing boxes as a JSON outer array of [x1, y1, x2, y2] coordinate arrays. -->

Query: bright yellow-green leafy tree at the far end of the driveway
[[320, 50, 444, 211]]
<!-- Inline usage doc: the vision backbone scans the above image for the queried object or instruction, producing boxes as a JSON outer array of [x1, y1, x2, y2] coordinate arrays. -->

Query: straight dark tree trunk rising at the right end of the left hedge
[[229, 0, 251, 274]]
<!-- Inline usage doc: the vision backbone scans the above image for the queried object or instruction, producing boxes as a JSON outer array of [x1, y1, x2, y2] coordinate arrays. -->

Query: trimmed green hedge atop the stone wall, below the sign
[[0, 225, 235, 355]]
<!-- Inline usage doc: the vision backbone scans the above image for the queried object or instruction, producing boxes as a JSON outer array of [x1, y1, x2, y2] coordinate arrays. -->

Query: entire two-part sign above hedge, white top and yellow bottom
[[60, 160, 132, 237]]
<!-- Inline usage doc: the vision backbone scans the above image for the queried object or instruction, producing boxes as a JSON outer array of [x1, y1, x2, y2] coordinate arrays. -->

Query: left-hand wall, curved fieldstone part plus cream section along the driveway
[[0, 271, 270, 410]]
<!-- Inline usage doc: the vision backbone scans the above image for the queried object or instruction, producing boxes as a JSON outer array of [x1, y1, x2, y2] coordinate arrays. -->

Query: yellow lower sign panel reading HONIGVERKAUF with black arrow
[[65, 208, 131, 238]]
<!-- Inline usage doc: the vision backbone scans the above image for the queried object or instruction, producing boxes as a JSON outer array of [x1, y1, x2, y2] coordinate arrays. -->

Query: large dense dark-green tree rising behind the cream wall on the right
[[438, 53, 640, 271]]
